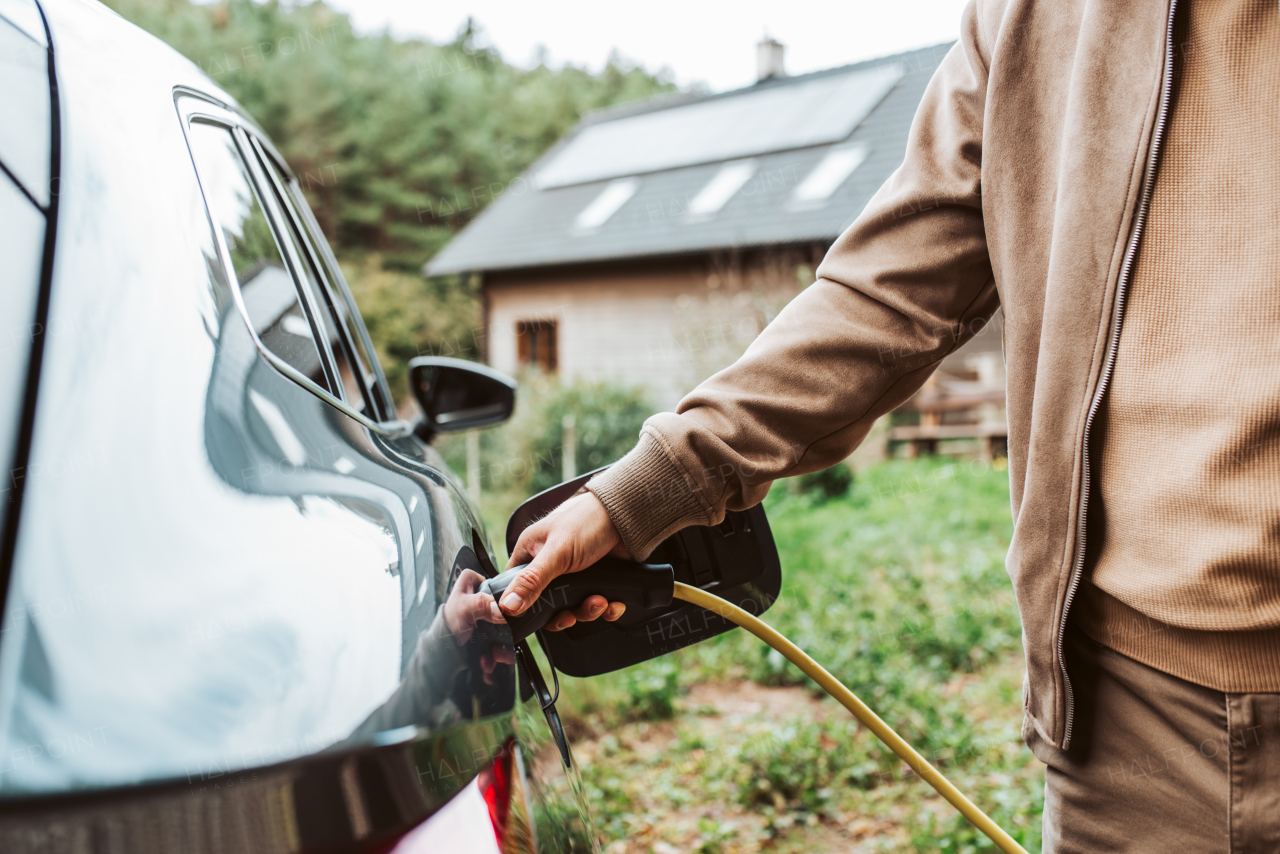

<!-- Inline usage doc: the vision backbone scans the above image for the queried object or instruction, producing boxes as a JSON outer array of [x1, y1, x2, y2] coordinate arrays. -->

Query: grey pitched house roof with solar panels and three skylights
[[426, 44, 950, 275]]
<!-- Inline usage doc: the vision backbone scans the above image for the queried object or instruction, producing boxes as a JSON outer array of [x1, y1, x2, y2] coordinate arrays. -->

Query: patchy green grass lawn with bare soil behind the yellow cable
[[504, 458, 1043, 854]]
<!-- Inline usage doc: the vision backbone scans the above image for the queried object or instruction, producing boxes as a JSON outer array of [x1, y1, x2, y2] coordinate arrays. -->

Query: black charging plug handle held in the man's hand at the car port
[[480, 557, 676, 643]]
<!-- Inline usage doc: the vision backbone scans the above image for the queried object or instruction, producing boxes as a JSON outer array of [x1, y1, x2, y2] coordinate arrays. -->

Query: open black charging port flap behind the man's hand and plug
[[507, 469, 782, 676]]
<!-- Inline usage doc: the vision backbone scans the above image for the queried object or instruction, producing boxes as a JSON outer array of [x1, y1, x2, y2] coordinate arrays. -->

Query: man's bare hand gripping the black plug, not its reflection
[[499, 490, 631, 631]]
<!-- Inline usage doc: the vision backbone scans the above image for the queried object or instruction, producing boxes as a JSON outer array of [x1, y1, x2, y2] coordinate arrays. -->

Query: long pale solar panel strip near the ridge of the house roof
[[536, 63, 904, 188]]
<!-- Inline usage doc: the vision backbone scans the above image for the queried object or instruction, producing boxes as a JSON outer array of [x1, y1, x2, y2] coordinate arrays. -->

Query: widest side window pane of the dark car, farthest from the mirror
[[189, 122, 337, 394]]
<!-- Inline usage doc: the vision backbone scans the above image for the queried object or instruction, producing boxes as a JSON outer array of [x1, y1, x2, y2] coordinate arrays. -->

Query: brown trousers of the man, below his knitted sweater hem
[[1023, 626, 1280, 854]]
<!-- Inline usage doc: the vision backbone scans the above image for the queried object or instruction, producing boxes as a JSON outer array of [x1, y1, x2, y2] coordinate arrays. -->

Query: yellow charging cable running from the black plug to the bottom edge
[[676, 581, 1027, 854]]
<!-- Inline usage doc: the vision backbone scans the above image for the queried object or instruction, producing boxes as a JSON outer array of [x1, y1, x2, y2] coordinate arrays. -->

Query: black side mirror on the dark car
[[408, 356, 516, 439]]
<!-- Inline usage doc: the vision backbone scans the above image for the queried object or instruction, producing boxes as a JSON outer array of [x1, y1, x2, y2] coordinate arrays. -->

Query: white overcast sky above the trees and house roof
[[322, 0, 964, 91]]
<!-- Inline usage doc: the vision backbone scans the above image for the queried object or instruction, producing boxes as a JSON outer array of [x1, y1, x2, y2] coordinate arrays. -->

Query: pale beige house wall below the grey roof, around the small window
[[484, 250, 820, 410]]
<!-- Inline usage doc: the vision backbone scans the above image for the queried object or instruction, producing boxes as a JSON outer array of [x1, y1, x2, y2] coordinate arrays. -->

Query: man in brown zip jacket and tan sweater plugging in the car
[[502, 0, 1280, 851]]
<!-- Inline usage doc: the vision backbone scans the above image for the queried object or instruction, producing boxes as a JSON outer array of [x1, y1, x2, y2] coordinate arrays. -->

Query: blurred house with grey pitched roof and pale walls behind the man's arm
[[426, 40, 1002, 458]]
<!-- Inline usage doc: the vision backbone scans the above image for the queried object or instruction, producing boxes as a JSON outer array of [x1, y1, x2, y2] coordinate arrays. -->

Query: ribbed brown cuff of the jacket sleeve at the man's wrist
[[586, 430, 710, 561]]
